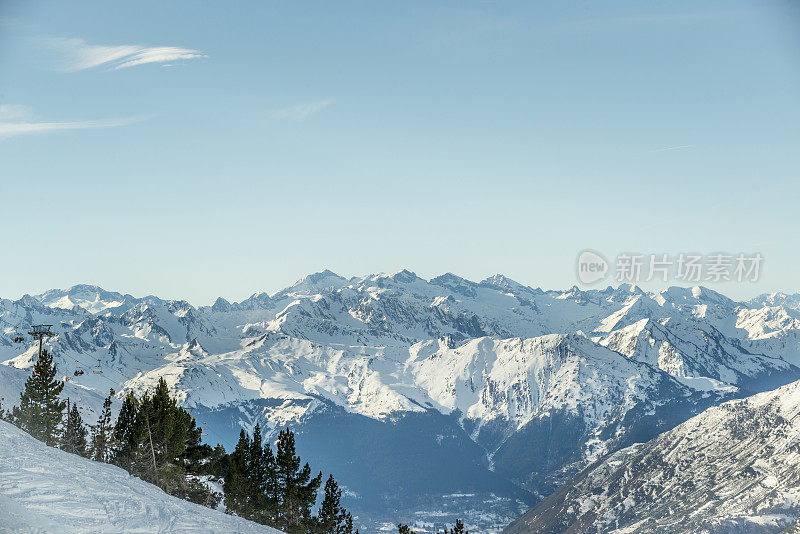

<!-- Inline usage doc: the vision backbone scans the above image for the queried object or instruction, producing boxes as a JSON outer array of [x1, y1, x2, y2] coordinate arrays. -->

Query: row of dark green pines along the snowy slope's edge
[[0, 351, 468, 534]]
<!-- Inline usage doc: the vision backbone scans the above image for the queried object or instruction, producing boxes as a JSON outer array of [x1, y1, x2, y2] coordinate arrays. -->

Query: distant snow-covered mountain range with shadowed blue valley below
[[0, 271, 800, 531]]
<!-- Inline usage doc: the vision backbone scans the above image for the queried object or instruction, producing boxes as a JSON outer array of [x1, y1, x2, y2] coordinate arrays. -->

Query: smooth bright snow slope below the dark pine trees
[[0, 421, 279, 534]]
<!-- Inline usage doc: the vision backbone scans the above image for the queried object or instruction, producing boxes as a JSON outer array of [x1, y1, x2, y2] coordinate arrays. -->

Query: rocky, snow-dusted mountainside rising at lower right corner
[[505, 382, 800, 534]]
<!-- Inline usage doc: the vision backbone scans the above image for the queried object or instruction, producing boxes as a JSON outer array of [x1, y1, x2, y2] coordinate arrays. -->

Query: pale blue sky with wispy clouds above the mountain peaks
[[0, 1, 800, 304]]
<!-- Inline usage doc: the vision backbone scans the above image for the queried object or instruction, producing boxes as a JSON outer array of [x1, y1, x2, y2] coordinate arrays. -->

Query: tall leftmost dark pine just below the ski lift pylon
[[12, 350, 67, 446]]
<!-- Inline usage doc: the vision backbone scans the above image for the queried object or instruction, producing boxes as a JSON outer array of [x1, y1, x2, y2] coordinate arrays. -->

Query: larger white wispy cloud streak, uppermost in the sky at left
[[43, 37, 208, 72]]
